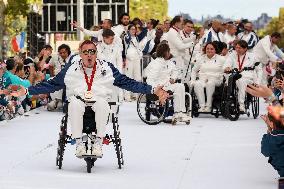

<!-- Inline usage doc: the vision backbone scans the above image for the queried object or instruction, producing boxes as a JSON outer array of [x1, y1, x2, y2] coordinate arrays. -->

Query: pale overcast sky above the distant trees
[[168, 0, 284, 20]]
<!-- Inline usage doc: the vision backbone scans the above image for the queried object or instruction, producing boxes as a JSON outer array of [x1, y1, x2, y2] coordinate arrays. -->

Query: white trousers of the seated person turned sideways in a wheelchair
[[163, 83, 186, 112]]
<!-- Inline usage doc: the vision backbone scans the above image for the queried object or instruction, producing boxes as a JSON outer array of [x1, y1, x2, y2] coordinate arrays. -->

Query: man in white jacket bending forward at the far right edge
[[253, 32, 284, 84]]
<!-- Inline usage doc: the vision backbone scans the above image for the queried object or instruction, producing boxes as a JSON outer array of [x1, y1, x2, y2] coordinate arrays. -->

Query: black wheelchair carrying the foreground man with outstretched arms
[[56, 99, 124, 173]]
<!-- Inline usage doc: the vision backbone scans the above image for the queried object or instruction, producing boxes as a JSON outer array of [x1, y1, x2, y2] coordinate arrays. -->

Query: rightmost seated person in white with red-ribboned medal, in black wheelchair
[[224, 40, 262, 112]]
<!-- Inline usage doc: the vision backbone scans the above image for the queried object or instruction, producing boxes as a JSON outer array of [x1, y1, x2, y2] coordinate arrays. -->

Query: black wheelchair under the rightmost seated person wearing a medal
[[223, 62, 259, 121]]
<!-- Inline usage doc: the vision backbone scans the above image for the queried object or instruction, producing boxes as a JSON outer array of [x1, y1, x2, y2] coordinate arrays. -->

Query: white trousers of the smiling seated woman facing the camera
[[193, 78, 222, 107]]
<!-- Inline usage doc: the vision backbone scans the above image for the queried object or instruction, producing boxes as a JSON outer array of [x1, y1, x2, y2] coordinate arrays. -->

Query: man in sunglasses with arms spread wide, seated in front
[[5, 40, 168, 157]]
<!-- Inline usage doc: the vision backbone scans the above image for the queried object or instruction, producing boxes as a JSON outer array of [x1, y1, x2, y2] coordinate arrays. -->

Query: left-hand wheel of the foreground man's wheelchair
[[56, 115, 67, 169]]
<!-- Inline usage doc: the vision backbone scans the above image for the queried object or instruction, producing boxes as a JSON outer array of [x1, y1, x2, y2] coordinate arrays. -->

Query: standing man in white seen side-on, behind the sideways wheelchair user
[[167, 16, 194, 79]]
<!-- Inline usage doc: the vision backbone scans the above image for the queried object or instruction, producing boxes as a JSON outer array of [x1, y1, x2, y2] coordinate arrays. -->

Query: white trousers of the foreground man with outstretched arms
[[68, 96, 110, 138]]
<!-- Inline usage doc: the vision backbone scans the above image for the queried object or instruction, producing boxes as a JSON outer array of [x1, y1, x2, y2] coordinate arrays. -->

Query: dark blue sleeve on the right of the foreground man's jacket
[[108, 63, 152, 94]]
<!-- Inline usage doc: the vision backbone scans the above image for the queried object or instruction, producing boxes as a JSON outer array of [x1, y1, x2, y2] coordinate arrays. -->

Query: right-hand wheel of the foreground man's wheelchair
[[112, 114, 124, 169]]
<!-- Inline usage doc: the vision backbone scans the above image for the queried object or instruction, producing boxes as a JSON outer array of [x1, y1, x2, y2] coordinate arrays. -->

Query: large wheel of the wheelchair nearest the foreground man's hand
[[137, 94, 168, 125]]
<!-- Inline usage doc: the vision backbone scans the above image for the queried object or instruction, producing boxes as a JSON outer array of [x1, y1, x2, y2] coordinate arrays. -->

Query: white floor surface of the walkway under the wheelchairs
[[0, 103, 278, 189]]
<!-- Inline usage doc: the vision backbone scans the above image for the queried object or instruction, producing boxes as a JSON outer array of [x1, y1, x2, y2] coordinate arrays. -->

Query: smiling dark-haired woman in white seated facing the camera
[[190, 42, 225, 112]]
